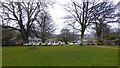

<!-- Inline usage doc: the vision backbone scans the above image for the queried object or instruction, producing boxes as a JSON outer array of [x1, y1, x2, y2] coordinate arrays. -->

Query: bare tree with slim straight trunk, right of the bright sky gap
[[65, 0, 94, 44]]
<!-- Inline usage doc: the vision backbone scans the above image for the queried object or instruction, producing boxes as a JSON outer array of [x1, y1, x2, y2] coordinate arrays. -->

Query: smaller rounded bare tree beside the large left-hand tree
[[33, 11, 56, 43]]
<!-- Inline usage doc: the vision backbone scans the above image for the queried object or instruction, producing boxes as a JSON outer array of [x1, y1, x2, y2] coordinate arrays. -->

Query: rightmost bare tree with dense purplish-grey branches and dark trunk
[[91, 1, 116, 43]]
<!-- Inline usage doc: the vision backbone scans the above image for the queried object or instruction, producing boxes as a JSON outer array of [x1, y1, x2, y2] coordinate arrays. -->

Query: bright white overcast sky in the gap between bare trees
[[49, 0, 120, 34]]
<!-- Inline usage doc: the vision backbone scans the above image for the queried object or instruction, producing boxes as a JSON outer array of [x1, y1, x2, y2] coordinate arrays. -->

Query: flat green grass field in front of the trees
[[2, 46, 118, 66]]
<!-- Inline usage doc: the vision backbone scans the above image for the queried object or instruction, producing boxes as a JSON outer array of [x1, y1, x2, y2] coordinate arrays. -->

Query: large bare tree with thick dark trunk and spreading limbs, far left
[[0, 0, 52, 43]]
